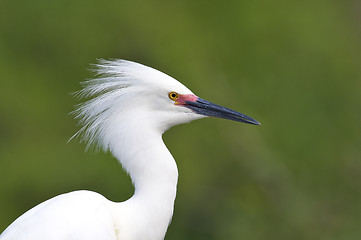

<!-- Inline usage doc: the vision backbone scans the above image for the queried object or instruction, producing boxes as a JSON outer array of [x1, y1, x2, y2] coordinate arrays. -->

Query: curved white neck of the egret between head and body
[[112, 124, 178, 239]]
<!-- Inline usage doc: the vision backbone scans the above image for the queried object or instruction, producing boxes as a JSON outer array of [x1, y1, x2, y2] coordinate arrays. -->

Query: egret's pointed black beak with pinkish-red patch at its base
[[178, 94, 261, 125]]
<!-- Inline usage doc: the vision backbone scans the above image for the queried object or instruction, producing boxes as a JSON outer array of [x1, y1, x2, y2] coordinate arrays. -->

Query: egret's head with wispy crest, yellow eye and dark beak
[[74, 60, 259, 149]]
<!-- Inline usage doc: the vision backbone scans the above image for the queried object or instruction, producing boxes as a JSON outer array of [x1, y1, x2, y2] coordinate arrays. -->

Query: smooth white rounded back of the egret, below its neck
[[1, 191, 117, 240]]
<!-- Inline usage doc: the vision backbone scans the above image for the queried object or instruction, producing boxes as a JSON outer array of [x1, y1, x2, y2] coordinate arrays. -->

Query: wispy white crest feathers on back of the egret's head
[[71, 59, 158, 150]]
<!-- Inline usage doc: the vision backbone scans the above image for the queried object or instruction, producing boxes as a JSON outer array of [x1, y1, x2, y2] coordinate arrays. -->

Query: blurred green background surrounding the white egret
[[0, 0, 361, 240]]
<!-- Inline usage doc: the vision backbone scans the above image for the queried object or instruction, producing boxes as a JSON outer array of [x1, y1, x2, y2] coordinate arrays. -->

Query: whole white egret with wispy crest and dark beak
[[0, 60, 259, 240]]
